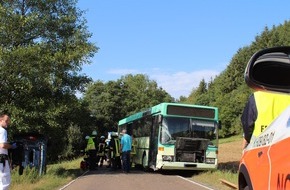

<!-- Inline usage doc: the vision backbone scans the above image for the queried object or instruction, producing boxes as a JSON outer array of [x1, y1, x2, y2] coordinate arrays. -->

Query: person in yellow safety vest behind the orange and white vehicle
[[241, 91, 290, 148]]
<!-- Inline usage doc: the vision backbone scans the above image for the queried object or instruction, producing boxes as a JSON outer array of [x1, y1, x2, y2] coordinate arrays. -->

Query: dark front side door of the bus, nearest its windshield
[[148, 116, 160, 169]]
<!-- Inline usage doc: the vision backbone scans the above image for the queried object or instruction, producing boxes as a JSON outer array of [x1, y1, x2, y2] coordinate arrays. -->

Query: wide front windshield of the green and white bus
[[160, 117, 216, 144]]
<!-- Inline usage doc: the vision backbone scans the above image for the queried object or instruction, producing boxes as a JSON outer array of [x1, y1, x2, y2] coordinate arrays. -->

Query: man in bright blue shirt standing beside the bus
[[121, 129, 132, 173]]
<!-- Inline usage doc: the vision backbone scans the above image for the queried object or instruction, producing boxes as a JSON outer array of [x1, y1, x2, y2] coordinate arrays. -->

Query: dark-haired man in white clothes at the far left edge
[[0, 114, 17, 190]]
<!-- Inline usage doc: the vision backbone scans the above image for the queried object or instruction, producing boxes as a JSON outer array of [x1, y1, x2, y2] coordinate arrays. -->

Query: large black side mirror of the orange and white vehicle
[[245, 46, 290, 93]]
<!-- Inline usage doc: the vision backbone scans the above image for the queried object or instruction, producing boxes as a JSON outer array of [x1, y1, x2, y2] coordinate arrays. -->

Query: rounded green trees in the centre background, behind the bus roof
[[84, 74, 173, 134]]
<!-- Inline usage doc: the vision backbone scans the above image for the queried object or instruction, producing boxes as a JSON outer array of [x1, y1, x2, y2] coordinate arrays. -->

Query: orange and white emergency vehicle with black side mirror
[[238, 47, 290, 190]]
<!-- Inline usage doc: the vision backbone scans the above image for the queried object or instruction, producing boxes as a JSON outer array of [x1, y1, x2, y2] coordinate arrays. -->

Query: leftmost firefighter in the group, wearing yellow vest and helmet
[[85, 131, 97, 170]]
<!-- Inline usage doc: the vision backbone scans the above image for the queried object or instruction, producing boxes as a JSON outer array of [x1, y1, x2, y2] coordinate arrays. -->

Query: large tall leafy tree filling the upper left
[[0, 0, 98, 162]]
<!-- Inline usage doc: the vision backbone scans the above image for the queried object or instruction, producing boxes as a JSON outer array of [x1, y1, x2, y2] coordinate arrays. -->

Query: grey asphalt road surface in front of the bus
[[59, 167, 213, 190]]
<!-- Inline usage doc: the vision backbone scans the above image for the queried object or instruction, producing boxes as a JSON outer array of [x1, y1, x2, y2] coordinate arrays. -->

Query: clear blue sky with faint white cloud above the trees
[[77, 0, 290, 98]]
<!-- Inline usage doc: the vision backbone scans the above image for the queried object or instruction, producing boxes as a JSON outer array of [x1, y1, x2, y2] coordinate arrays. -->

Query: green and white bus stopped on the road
[[118, 103, 221, 171]]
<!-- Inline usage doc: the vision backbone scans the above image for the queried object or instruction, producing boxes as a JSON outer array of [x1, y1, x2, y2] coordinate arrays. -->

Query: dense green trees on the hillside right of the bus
[[187, 21, 290, 137]]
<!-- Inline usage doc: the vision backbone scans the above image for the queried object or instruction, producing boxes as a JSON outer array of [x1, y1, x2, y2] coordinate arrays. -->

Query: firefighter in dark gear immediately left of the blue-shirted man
[[109, 132, 122, 170]]
